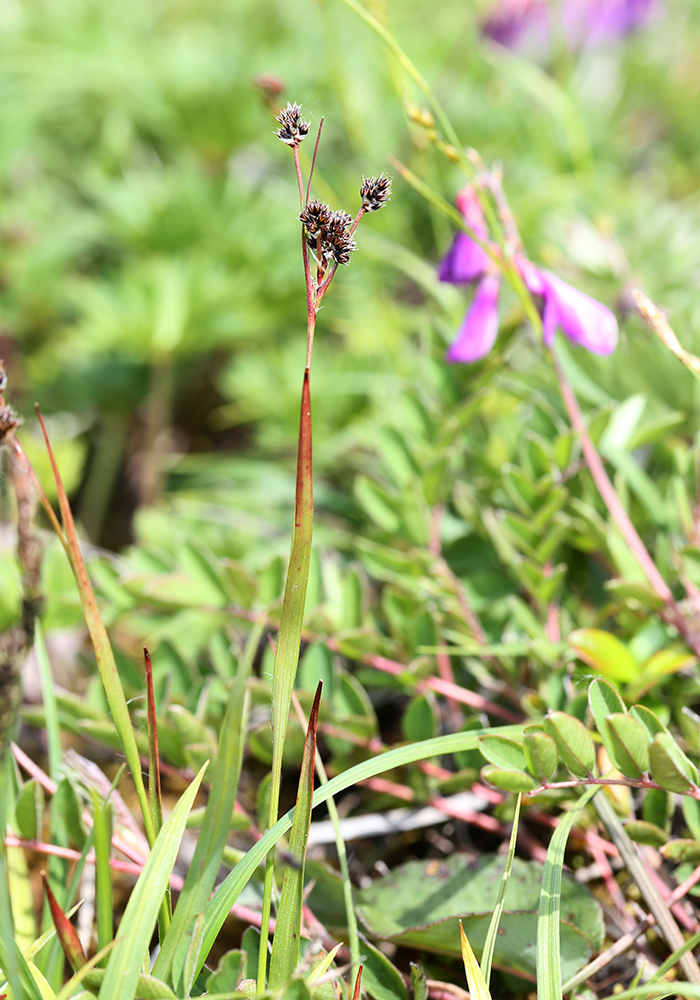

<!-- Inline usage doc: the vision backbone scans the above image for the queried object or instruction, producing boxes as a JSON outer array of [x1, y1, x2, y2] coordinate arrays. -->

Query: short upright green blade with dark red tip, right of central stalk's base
[[270, 681, 322, 990]]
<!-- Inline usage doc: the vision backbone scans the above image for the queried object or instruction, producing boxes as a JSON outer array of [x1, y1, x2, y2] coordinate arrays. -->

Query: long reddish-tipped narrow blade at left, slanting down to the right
[[37, 408, 155, 844]]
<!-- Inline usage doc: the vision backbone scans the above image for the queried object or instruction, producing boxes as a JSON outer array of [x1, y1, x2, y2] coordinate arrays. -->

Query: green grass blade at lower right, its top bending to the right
[[537, 785, 598, 1000]]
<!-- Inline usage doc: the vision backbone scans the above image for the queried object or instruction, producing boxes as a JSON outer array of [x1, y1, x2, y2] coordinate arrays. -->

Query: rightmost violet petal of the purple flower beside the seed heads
[[540, 271, 617, 354]]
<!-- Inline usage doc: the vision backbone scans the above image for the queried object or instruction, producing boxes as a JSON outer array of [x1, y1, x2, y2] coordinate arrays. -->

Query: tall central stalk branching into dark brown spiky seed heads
[[258, 103, 391, 992]]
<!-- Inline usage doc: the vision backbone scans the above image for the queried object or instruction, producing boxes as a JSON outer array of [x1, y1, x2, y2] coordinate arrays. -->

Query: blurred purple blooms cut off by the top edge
[[481, 0, 661, 51]]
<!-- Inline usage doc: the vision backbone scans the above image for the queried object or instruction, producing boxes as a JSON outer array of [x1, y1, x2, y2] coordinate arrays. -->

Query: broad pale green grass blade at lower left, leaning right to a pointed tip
[[99, 762, 208, 1000]]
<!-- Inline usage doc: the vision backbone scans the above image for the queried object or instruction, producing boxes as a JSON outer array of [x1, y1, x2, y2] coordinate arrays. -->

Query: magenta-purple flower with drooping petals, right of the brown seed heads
[[438, 185, 617, 364]]
